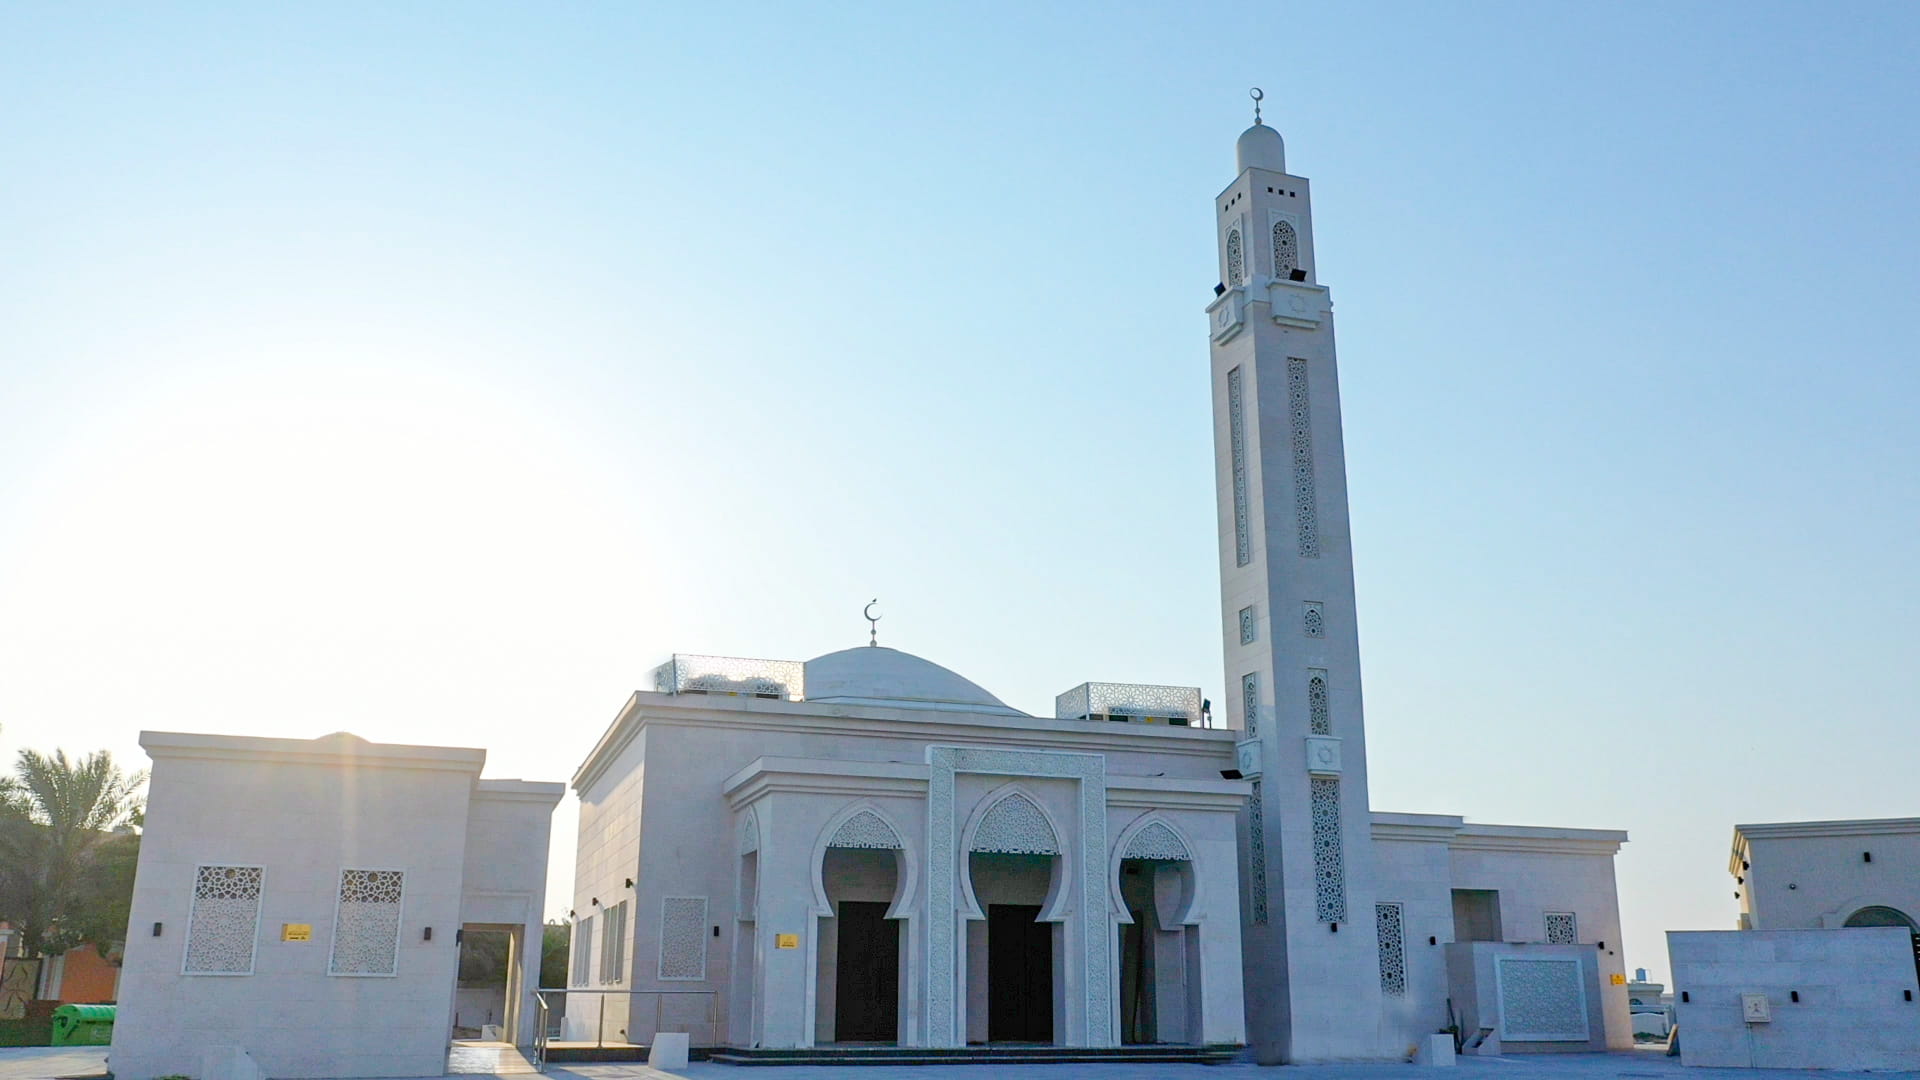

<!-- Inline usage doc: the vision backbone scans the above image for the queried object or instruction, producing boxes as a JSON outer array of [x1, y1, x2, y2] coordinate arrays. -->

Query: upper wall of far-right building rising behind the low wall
[[1734, 822, 1920, 930]]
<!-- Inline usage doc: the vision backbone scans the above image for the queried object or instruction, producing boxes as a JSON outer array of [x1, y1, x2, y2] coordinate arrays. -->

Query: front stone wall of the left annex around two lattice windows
[[113, 740, 480, 1080]]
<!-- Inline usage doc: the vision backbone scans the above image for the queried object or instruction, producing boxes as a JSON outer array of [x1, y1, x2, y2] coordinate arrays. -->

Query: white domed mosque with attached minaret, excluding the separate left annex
[[566, 105, 1632, 1063]]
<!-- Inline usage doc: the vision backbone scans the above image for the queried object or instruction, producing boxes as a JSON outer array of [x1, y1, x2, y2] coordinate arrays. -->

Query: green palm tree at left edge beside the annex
[[0, 749, 146, 953]]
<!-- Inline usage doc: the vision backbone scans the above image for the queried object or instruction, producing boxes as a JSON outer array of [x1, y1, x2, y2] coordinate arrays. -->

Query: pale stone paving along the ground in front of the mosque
[[0, 1047, 1920, 1080]]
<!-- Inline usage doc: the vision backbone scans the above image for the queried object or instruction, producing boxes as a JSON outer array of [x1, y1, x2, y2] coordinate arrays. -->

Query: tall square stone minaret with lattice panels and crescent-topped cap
[[1208, 90, 1404, 1063]]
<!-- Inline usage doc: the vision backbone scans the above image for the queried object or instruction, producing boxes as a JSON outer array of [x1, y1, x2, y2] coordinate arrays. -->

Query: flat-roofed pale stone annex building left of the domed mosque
[[111, 732, 564, 1080]]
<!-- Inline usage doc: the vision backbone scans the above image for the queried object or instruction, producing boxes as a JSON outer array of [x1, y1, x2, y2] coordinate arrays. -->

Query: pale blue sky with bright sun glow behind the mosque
[[0, 2, 1920, 974]]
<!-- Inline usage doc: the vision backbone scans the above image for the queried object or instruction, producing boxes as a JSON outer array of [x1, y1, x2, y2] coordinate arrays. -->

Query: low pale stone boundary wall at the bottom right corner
[[1667, 926, 1920, 1068]]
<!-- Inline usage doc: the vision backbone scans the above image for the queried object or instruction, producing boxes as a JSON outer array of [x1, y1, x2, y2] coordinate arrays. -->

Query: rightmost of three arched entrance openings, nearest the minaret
[[1119, 822, 1200, 1043]]
